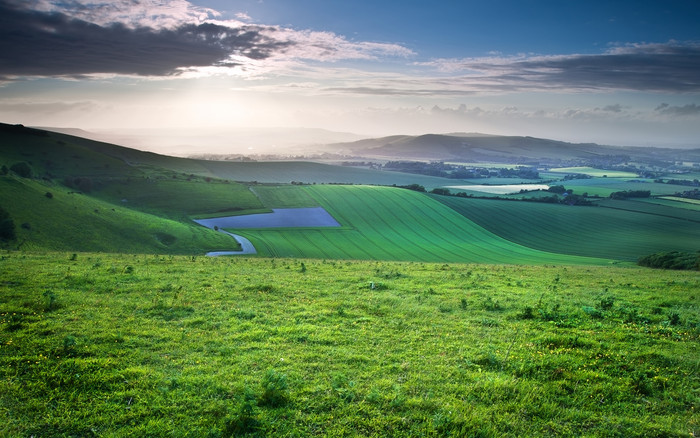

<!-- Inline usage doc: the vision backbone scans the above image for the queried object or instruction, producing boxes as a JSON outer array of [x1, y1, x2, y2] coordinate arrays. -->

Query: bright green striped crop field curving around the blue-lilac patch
[[228, 186, 611, 265]]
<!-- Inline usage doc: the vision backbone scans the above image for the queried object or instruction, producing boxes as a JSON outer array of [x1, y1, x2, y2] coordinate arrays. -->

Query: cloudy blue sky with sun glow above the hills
[[0, 0, 700, 151]]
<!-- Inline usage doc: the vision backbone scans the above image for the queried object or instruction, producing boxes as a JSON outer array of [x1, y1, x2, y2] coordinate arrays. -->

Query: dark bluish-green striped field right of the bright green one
[[434, 196, 700, 261]]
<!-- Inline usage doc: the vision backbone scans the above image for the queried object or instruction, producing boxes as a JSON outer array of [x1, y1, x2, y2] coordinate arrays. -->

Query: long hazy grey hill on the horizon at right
[[326, 133, 700, 163]]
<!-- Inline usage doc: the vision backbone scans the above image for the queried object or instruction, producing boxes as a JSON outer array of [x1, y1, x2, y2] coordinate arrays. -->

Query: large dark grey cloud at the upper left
[[0, 0, 291, 78]]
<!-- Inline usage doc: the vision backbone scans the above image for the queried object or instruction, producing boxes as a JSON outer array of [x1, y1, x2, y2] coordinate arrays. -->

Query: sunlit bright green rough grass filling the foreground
[[0, 253, 700, 437]]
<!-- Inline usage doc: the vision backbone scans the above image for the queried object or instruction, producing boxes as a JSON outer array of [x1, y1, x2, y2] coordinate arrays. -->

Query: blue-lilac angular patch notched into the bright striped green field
[[195, 207, 340, 229]]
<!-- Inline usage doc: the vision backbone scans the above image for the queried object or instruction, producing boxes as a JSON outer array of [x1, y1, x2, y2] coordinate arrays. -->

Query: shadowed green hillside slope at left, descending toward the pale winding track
[[0, 176, 232, 254]]
